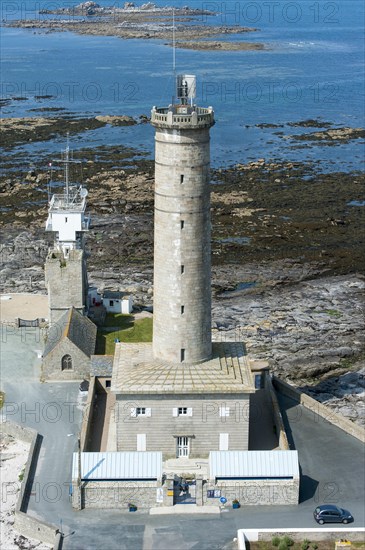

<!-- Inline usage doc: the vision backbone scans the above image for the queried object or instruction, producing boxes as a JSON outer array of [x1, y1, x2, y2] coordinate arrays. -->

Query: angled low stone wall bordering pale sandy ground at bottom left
[[1, 421, 62, 549]]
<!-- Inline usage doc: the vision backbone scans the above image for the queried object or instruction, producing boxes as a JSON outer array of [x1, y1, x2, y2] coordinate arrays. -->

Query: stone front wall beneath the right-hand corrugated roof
[[203, 479, 299, 506]]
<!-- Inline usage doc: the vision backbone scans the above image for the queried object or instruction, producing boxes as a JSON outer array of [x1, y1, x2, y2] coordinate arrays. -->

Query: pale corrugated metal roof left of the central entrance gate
[[72, 451, 162, 480]]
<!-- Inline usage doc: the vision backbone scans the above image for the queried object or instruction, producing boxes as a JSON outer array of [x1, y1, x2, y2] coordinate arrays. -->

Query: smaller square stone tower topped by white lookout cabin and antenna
[[45, 145, 90, 325]]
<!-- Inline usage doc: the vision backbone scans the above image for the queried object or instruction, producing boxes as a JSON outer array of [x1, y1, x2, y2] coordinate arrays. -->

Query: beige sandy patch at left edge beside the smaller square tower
[[0, 294, 48, 323]]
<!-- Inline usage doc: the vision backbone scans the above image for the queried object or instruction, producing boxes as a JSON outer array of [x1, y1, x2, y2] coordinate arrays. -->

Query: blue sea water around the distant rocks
[[0, 0, 365, 171]]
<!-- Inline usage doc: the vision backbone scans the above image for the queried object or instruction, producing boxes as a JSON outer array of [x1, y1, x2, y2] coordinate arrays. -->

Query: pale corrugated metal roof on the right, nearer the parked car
[[209, 451, 299, 479]]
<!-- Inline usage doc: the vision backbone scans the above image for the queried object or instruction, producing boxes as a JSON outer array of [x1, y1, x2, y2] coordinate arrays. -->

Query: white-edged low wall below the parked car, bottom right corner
[[237, 527, 365, 550]]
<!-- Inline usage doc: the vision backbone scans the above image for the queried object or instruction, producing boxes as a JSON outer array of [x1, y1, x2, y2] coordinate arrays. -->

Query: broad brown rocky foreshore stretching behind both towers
[[0, 116, 365, 424]]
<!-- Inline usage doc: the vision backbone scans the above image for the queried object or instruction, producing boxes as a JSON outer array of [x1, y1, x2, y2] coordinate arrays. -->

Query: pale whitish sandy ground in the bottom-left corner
[[0, 436, 51, 550]]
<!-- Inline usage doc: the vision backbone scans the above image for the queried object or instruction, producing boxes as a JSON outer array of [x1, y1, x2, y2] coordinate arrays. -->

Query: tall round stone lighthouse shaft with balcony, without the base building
[[151, 75, 214, 364]]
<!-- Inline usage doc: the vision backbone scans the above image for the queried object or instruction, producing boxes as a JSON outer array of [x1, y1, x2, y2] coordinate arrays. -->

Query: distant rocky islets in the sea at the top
[[6, 2, 264, 50]]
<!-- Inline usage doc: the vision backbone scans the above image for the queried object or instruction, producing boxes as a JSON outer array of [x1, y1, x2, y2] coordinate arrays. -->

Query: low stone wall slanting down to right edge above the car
[[273, 376, 365, 443]]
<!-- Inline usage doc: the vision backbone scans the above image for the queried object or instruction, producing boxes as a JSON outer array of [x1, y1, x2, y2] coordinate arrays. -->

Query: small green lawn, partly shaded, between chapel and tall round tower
[[96, 315, 152, 355]]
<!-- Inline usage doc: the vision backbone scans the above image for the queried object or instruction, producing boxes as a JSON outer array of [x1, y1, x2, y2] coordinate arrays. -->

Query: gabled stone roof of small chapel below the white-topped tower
[[43, 307, 97, 357]]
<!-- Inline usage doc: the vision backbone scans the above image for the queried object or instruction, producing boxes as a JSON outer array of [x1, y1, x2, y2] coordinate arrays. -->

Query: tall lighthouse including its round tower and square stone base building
[[108, 75, 255, 462]]
